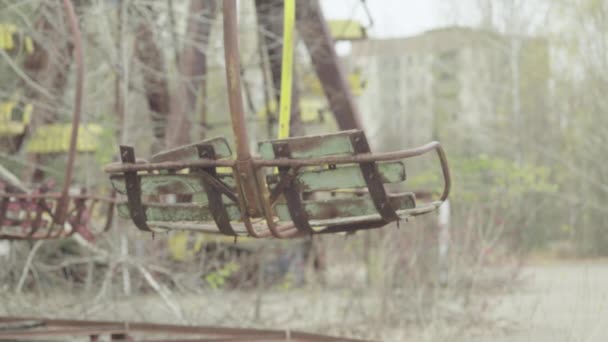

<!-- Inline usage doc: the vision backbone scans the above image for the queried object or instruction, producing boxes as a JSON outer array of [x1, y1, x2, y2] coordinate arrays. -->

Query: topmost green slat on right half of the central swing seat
[[258, 130, 356, 159]]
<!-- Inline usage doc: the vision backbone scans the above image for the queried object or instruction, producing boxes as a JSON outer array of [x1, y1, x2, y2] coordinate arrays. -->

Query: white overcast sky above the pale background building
[[321, 0, 479, 38]]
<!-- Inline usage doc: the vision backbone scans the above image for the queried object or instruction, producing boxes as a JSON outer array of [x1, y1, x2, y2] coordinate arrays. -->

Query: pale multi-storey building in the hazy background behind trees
[[349, 27, 549, 155]]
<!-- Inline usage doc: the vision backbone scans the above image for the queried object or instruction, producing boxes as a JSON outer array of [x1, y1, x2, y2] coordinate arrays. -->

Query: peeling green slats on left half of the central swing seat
[[110, 138, 247, 235]]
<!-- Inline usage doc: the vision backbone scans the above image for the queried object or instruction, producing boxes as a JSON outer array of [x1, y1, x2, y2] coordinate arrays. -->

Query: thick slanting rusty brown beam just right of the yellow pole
[[296, 0, 362, 130]]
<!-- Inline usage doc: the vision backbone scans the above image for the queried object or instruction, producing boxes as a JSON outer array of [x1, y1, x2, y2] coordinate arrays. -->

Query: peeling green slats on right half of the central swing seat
[[259, 130, 416, 232]]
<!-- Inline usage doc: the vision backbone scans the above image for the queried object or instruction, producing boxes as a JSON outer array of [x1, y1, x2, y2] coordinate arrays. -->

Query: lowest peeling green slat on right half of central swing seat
[[275, 193, 416, 225]]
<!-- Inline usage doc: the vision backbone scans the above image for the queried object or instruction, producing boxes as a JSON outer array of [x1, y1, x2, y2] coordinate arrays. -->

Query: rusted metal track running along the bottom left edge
[[0, 317, 370, 342]]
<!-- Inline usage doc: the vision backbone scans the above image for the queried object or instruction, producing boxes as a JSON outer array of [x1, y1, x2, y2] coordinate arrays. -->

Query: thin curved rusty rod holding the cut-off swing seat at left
[[55, 0, 84, 224]]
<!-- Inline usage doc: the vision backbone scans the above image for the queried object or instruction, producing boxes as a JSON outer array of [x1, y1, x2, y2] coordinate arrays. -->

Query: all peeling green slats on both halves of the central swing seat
[[110, 130, 415, 235]]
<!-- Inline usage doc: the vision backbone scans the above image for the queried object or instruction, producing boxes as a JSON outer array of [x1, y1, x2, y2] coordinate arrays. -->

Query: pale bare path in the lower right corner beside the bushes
[[473, 260, 608, 342]]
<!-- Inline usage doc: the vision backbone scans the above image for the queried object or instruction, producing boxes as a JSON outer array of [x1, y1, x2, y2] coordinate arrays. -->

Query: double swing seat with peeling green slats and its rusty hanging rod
[[105, 0, 450, 238]]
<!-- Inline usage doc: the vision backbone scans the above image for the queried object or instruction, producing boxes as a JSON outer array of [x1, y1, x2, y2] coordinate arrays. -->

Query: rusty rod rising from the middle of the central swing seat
[[223, 0, 251, 161]]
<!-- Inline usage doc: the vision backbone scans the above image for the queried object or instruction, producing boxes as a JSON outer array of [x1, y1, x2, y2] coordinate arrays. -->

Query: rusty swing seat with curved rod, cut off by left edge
[[0, 0, 115, 241]]
